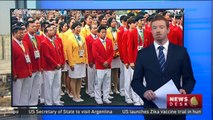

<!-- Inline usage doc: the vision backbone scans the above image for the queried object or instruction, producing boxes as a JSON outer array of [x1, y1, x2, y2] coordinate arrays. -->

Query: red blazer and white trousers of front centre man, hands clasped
[[92, 38, 113, 104]]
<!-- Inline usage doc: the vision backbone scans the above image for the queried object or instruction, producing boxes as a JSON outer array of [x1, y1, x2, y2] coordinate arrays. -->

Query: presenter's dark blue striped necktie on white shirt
[[158, 46, 166, 72]]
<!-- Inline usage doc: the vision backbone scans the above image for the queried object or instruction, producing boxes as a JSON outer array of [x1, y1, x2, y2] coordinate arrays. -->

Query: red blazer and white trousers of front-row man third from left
[[41, 37, 61, 105]]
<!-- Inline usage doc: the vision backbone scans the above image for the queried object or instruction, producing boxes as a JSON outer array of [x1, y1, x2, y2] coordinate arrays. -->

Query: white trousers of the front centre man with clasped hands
[[95, 69, 111, 101]]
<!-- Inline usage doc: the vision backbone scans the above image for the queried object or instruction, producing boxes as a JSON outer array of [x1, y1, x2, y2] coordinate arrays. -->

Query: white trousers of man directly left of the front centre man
[[87, 65, 96, 95]]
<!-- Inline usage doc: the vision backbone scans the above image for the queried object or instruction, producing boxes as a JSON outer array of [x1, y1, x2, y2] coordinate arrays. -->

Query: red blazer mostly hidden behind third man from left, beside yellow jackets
[[55, 36, 65, 65]]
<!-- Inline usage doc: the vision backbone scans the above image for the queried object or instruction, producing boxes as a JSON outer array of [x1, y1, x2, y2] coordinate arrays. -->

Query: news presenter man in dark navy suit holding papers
[[131, 15, 195, 120]]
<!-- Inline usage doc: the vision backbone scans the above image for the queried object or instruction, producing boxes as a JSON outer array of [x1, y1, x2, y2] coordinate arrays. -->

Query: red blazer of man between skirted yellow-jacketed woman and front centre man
[[86, 34, 95, 64]]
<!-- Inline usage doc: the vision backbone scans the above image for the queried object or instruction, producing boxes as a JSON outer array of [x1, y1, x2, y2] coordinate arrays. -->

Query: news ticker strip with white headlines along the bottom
[[0, 109, 202, 115]]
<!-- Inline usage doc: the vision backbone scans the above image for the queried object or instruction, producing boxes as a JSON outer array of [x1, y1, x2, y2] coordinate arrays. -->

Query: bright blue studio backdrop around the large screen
[[36, 0, 212, 120]]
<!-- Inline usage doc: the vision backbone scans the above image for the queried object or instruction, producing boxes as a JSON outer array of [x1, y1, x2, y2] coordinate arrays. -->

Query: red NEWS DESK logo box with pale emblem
[[167, 94, 202, 108]]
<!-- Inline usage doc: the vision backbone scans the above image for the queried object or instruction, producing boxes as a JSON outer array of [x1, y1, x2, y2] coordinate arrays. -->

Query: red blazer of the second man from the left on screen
[[23, 33, 41, 72]]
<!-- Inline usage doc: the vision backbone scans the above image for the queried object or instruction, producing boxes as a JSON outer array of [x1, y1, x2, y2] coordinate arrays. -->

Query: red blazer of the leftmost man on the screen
[[12, 40, 32, 78]]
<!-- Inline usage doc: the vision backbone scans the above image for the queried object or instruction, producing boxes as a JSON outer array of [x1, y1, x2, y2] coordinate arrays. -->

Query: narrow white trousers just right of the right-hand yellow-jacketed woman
[[119, 63, 125, 93]]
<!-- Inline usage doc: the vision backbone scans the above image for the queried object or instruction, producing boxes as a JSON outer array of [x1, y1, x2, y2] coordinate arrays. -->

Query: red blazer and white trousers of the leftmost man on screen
[[12, 39, 32, 106]]
